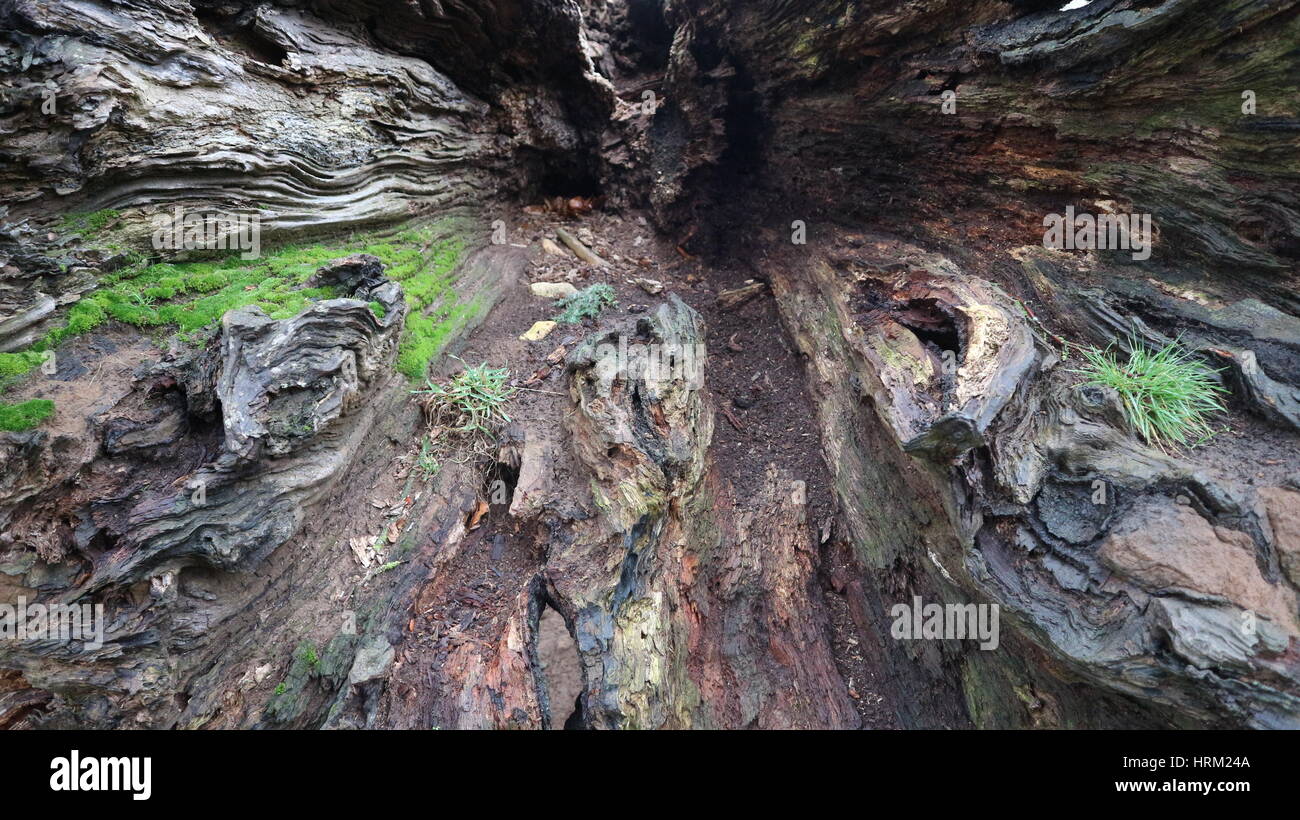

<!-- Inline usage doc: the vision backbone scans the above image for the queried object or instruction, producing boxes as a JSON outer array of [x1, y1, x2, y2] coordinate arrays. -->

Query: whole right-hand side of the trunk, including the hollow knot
[[653, 0, 1300, 726]]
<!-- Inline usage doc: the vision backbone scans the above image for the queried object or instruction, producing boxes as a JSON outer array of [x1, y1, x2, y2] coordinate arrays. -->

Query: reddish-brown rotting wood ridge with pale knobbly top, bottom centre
[[374, 298, 858, 729]]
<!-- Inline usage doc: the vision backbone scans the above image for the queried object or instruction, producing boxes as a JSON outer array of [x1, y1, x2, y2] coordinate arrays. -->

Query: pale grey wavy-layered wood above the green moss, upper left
[[3, 0, 610, 230]]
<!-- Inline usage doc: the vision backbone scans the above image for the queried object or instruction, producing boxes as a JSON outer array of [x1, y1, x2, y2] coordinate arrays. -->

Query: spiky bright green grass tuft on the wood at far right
[[1073, 337, 1227, 450]]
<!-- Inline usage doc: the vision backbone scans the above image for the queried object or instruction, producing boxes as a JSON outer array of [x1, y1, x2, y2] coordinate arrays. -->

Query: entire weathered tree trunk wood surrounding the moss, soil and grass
[[0, 0, 1300, 728]]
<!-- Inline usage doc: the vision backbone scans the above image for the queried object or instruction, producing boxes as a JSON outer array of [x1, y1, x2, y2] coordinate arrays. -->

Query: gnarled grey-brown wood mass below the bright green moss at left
[[4, 240, 521, 726]]
